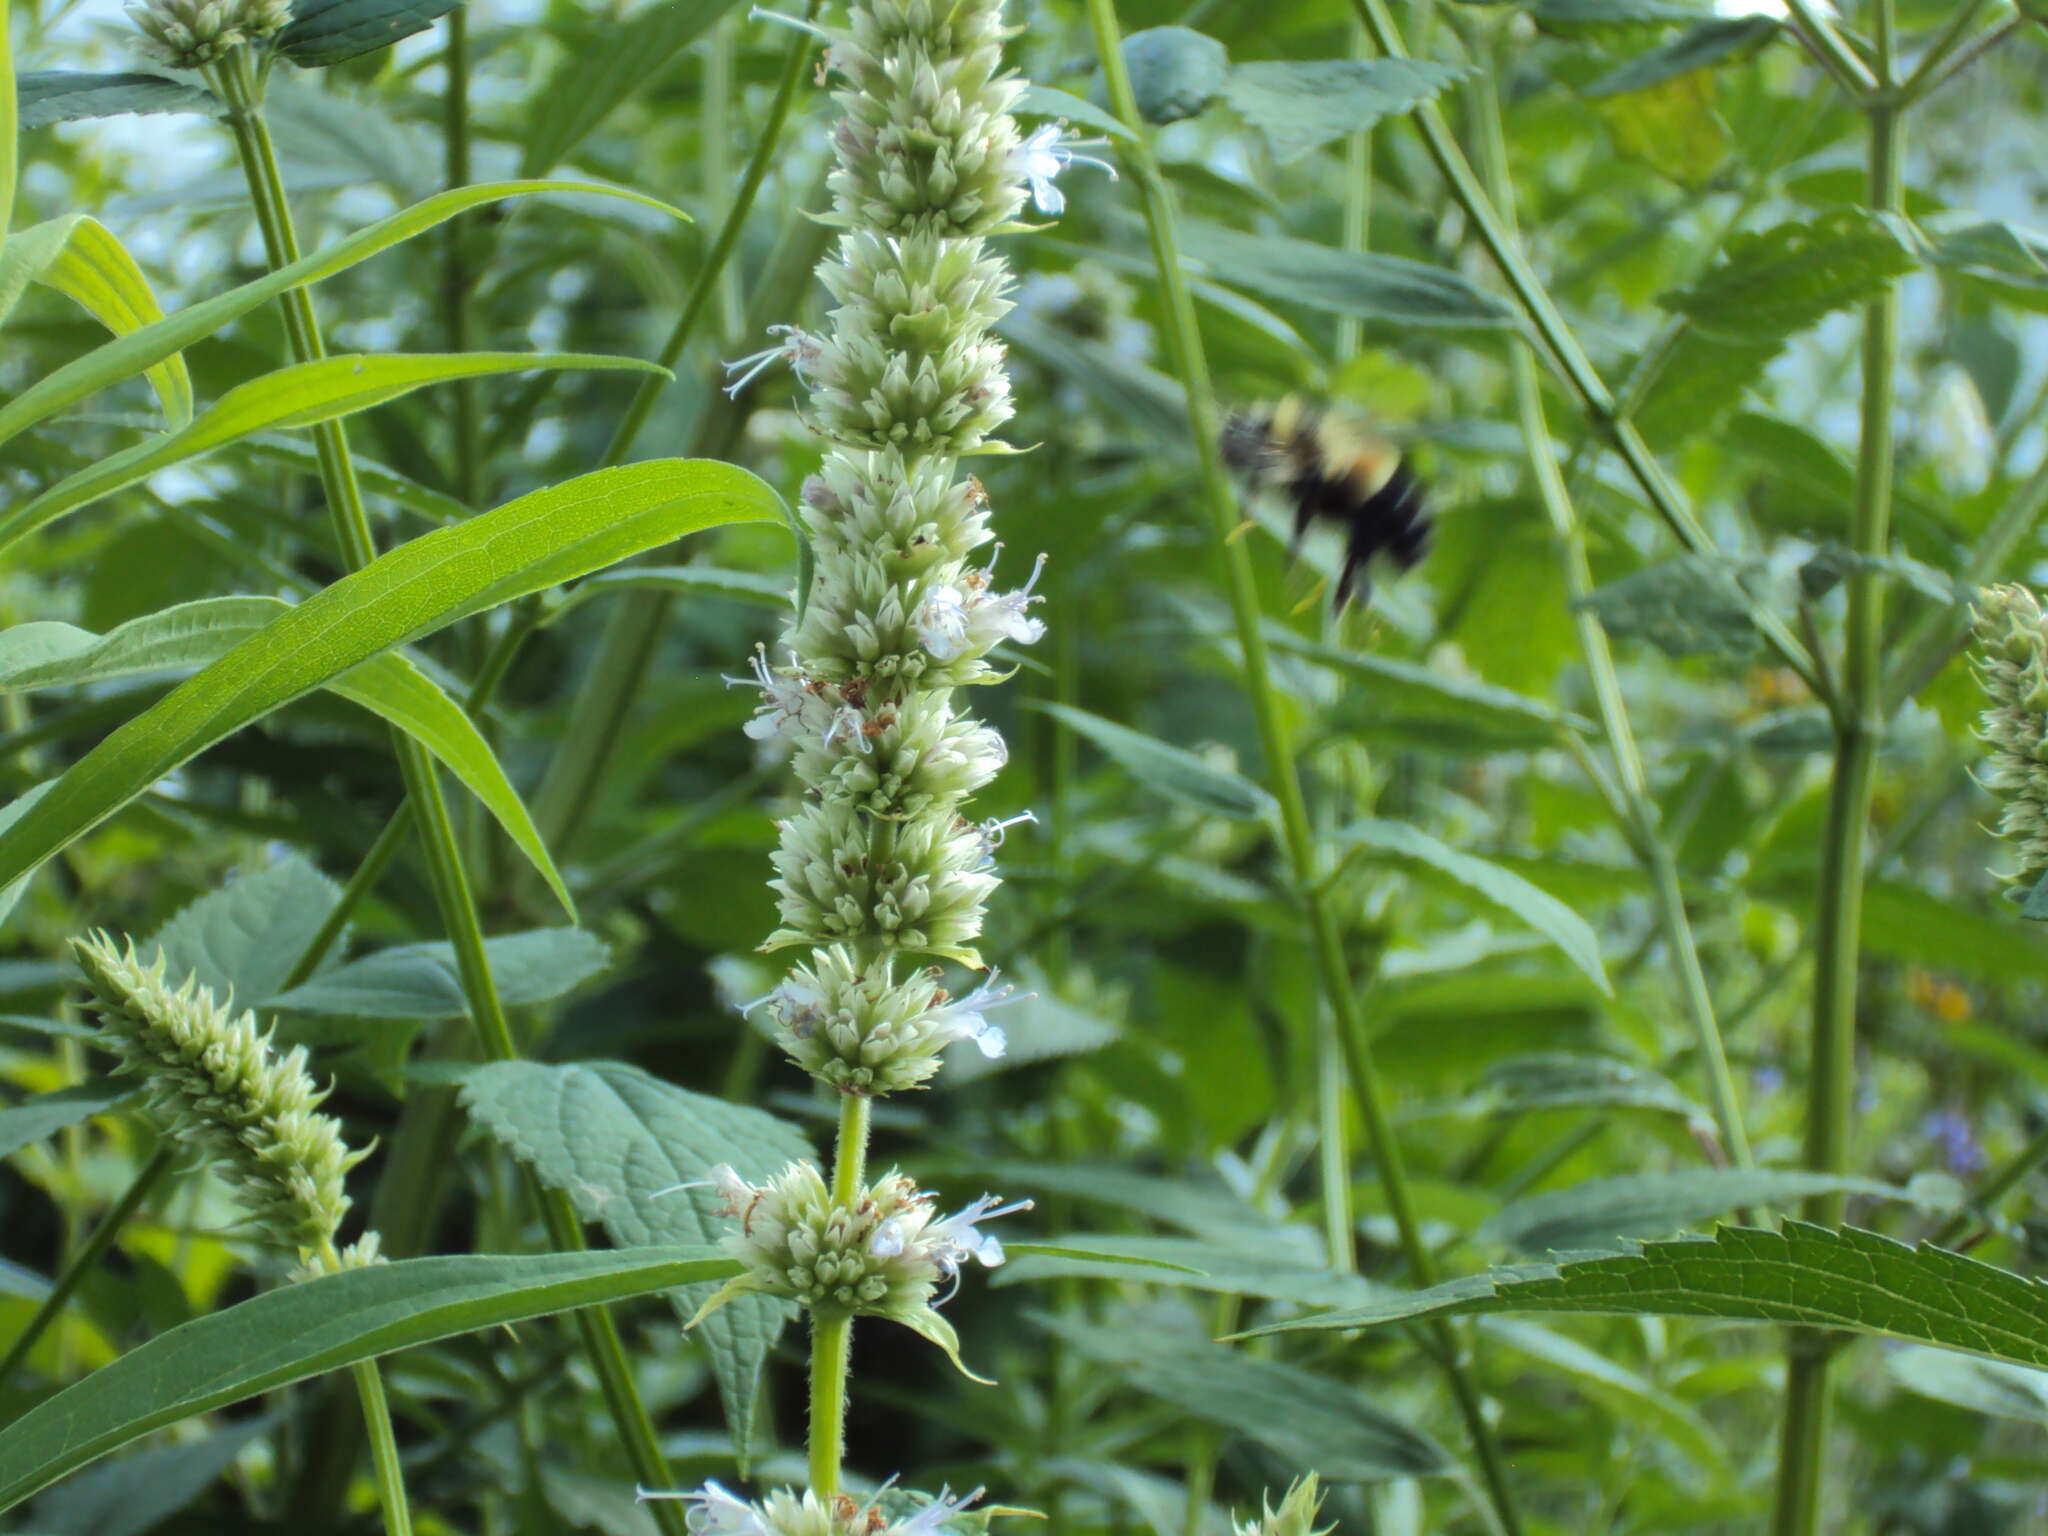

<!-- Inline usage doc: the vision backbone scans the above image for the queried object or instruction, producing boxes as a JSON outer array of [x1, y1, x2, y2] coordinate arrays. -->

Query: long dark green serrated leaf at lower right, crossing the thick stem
[[1241, 1221, 2048, 1366]]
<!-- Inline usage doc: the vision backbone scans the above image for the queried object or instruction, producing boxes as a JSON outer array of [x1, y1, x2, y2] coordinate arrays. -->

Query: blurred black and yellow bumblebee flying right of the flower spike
[[1221, 395, 1430, 612]]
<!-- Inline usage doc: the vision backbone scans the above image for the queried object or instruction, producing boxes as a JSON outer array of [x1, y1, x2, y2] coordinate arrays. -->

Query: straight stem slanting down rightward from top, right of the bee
[[1352, 0, 1827, 700]]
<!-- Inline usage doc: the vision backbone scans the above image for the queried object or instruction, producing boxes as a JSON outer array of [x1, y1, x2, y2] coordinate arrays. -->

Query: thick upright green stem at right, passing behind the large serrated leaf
[[1774, 0, 1903, 1536]]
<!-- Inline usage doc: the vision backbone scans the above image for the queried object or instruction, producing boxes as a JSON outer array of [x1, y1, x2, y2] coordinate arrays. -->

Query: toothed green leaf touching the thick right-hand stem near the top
[[1663, 209, 1919, 344]]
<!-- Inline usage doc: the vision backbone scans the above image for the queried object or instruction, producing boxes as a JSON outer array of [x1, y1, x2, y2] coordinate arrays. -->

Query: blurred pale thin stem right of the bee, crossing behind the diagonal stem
[[1475, 45, 1753, 1167]]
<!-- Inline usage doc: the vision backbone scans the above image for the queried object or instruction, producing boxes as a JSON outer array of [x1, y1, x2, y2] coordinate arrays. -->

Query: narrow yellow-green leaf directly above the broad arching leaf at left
[[0, 352, 666, 551]]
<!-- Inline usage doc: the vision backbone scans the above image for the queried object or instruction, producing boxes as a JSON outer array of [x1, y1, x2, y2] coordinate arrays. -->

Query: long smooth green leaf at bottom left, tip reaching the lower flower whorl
[[0, 1247, 739, 1509]]
